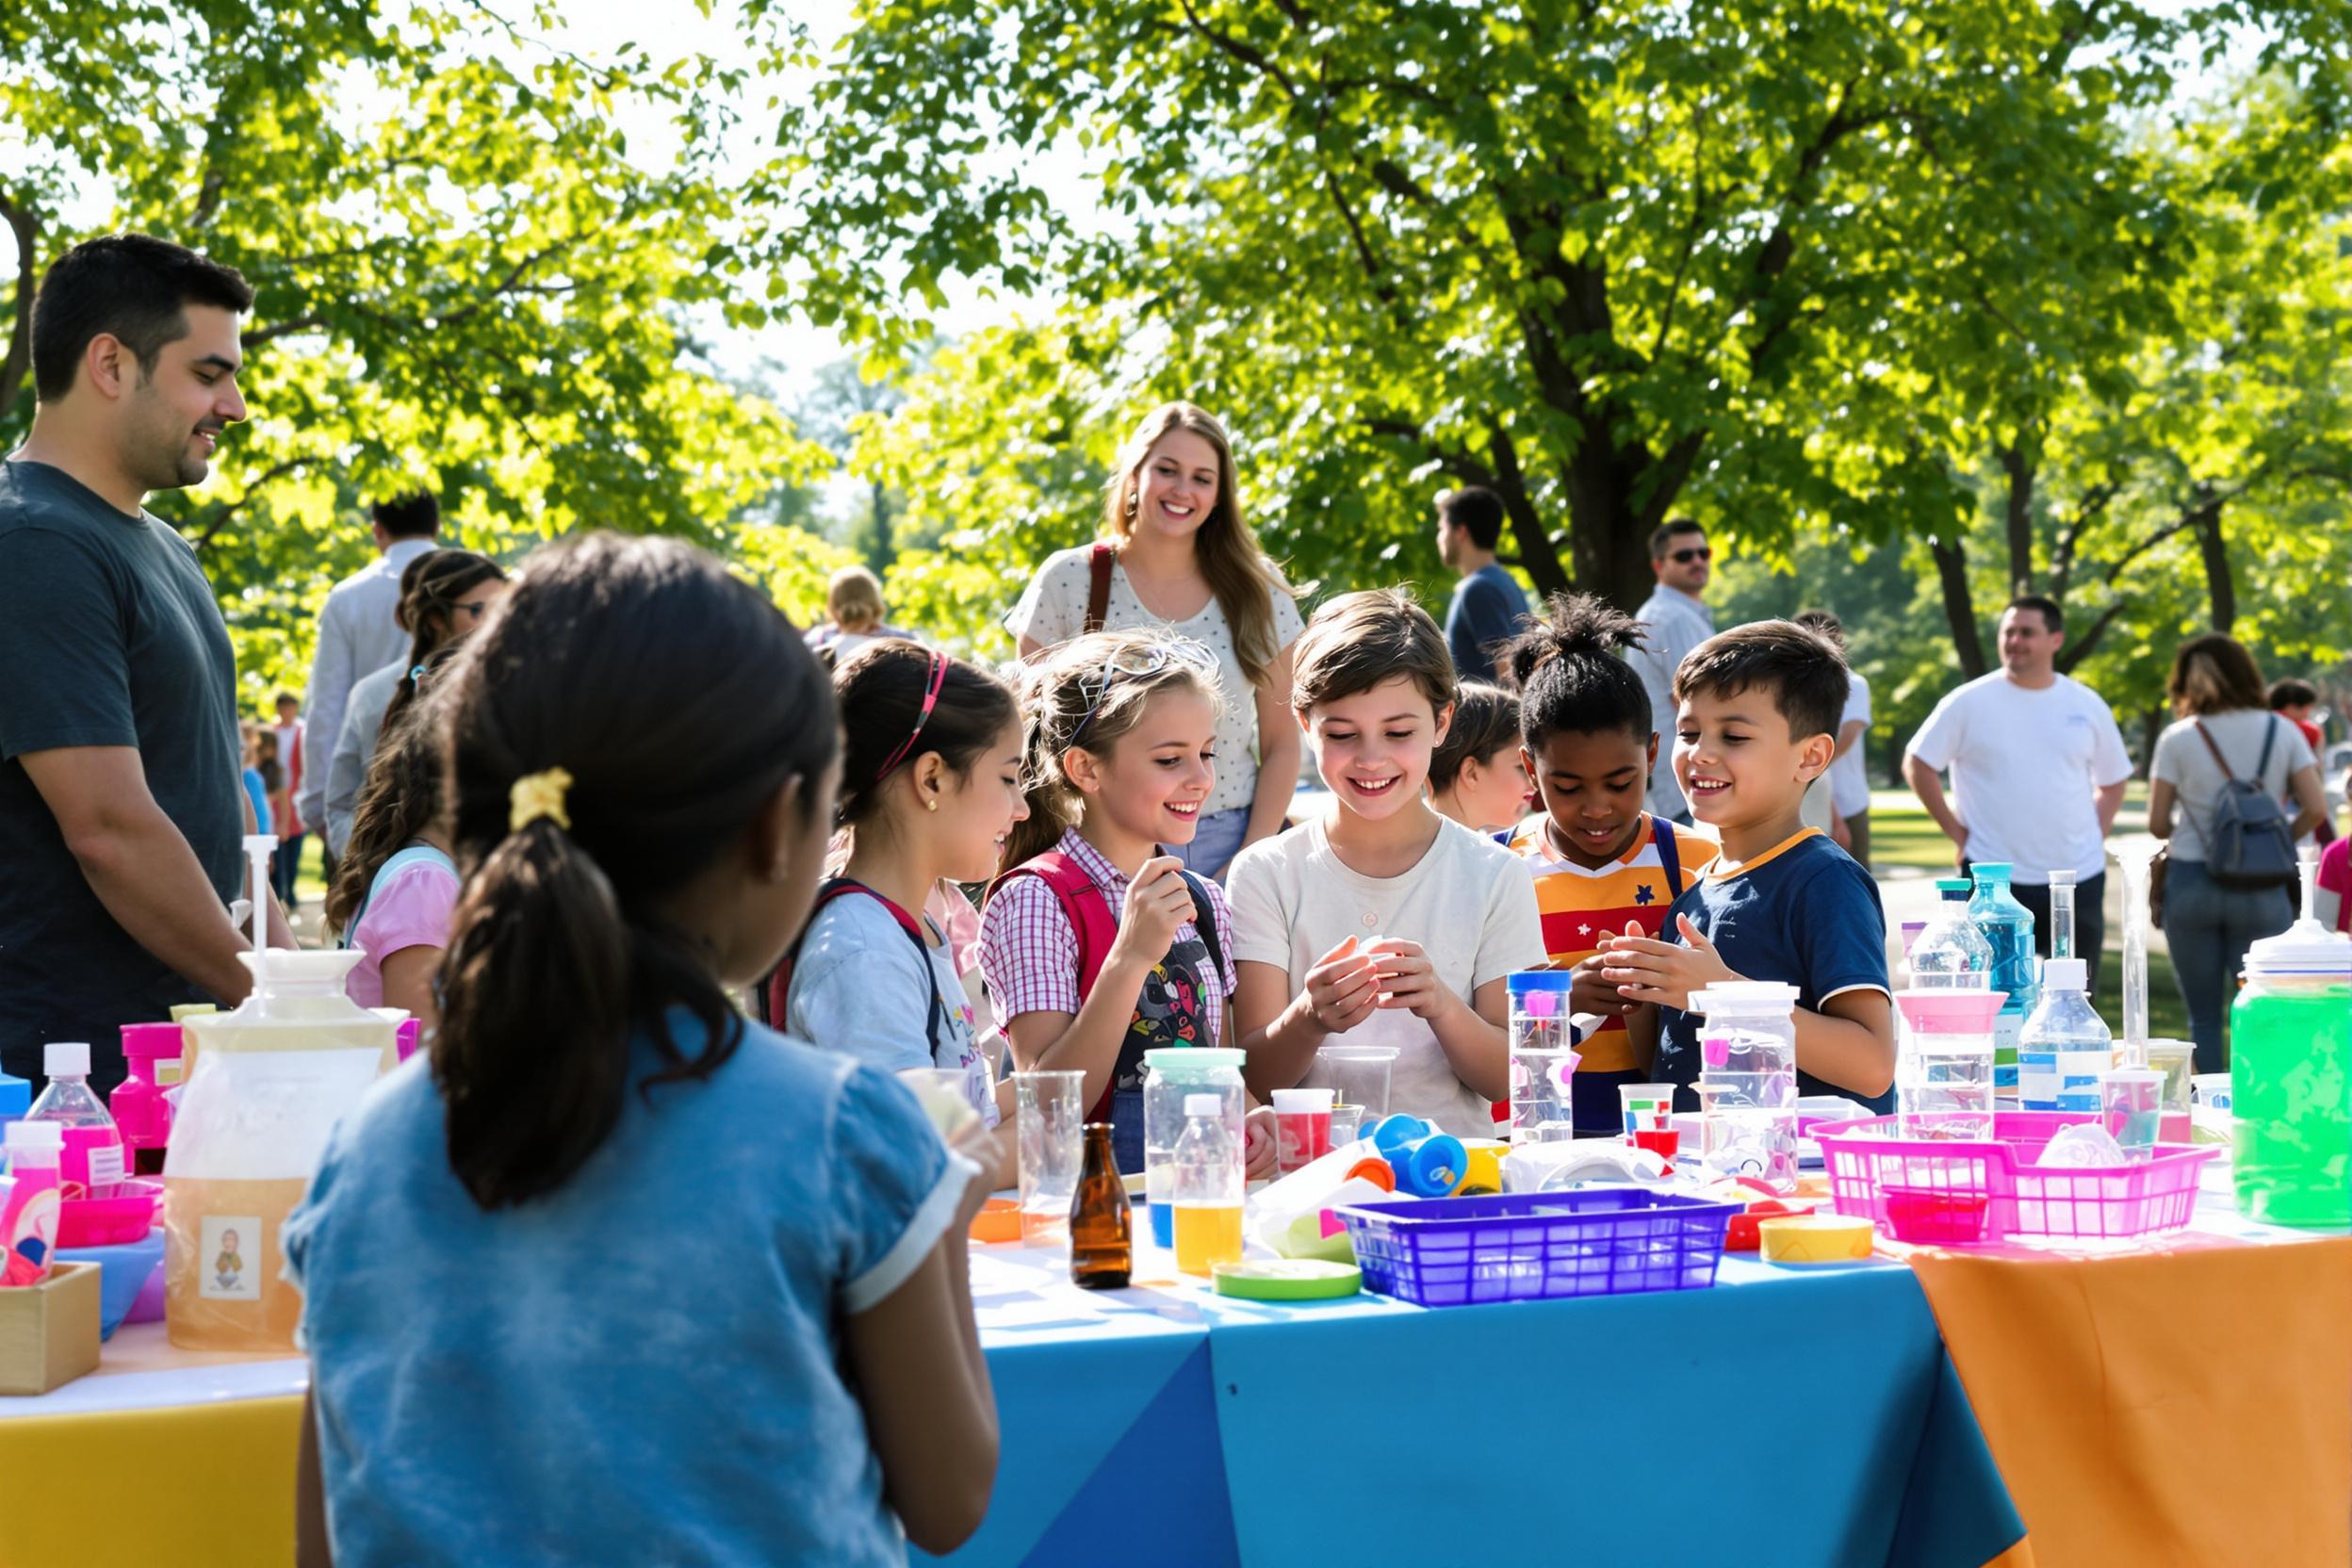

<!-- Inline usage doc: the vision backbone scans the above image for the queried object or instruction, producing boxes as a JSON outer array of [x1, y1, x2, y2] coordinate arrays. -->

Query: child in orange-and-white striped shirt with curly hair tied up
[[1498, 593, 1720, 1133]]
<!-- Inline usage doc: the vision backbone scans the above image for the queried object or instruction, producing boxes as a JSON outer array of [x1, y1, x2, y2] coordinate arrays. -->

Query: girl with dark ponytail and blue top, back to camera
[[287, 533, 997, 1568]]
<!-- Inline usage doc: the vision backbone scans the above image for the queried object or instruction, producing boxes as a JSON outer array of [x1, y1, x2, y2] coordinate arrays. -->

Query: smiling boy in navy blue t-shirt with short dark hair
[[1599, 621, 1896, 1115]]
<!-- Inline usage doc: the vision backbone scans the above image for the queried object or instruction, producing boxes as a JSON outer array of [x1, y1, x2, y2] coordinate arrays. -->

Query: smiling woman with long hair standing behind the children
[[1004, 402, 1305, 877]]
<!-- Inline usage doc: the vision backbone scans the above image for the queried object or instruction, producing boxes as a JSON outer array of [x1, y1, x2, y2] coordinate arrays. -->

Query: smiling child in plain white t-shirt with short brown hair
[[1233, 593, 1545, 1137]]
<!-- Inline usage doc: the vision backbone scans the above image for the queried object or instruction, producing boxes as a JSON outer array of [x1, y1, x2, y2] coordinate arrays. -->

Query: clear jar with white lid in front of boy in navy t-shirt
[[1691, 980, 1797, 1192]]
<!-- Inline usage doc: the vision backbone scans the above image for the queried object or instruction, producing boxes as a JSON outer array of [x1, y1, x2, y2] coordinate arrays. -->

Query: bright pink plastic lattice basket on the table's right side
[[1813, 1112, 2220, 1246]]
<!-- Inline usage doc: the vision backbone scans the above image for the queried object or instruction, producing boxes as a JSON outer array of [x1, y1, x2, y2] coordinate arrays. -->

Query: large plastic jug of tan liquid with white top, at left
[[162, 947, 395, 1354]]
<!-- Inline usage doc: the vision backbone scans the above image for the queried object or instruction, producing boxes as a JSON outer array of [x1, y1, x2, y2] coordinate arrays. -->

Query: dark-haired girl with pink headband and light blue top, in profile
[[769, 640, 1028, 1187]]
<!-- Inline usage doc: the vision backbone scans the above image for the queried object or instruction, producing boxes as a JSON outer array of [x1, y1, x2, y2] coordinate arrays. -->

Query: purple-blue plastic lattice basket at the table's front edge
[[1336, 1187, 1740, 1307]]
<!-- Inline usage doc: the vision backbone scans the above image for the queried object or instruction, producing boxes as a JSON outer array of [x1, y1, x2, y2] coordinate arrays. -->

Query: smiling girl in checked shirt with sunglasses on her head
[[981, 632, 1275, 1175]]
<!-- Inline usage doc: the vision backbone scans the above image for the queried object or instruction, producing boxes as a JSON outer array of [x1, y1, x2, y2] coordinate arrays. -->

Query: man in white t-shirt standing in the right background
[[1903, 595, 2131, 988]]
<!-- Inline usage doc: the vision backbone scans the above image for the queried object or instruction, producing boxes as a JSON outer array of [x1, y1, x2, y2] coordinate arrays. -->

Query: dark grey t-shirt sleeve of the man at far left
[[0, 527, 139, 757]]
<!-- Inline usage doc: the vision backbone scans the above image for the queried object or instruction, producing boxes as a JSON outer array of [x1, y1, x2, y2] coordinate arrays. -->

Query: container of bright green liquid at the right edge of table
[[2228, 851, 2352, 1227]]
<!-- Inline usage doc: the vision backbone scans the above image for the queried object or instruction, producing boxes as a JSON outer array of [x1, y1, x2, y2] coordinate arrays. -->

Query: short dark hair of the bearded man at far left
[[33, 235, 254, 402]]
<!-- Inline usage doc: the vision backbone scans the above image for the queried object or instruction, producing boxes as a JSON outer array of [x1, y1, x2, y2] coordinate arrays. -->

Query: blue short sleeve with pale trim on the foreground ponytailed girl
[[828, 1068, 972, 1315]]
